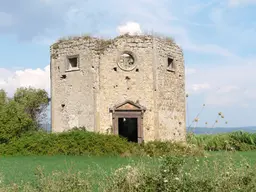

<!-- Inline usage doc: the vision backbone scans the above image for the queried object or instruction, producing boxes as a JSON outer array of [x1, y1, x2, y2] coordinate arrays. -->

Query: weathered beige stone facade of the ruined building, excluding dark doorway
[[51, 35, 186, 142]]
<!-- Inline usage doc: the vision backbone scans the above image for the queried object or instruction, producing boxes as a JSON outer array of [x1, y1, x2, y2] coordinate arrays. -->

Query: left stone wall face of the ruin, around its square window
[[51, 38, 99, 132]]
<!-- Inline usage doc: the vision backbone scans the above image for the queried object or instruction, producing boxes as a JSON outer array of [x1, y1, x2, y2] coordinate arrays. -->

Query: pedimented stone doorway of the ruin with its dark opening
[[110, 100, 146, 143]]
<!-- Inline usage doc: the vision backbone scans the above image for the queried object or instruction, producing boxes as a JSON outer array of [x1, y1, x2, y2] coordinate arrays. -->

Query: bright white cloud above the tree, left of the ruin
[[0, 65, 50, 96]]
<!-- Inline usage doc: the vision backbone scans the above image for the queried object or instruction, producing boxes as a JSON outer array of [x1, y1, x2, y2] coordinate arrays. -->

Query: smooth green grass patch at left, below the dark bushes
[[0, 155, 157, 188]]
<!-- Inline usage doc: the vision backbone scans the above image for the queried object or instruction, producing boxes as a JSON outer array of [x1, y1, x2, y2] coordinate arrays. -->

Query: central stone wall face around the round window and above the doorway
[[97, 37, 155, 141]]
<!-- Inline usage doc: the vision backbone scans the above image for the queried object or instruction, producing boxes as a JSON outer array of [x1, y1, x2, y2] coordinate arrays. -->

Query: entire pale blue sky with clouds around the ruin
[[0, 0, 256, 127]]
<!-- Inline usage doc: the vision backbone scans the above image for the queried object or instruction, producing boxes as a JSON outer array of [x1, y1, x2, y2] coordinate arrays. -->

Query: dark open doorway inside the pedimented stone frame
[[118, 118, 138, 143]]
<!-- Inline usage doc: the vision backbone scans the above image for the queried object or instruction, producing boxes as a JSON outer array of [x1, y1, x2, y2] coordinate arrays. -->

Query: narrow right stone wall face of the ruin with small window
[[155, 39, 186, 141]]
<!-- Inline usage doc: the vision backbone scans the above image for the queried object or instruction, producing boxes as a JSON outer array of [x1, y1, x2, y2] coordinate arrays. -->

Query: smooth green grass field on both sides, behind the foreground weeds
[[0, 151, 256, 190]]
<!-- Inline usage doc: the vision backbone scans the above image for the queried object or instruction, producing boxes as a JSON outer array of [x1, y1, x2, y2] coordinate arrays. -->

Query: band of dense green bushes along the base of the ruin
[[0, 129, 256, 156]]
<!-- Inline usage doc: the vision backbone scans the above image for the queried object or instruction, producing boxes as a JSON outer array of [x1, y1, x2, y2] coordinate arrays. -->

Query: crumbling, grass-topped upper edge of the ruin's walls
[[50, 34, 180, 49]]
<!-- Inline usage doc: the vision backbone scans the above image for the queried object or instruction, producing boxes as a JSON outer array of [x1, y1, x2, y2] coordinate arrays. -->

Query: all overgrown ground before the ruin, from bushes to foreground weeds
[[0, 129, 256, 192]]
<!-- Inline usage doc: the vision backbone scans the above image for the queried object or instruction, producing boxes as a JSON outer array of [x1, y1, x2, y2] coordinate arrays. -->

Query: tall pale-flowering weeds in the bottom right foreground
[[104, 156, 256, 192]]
